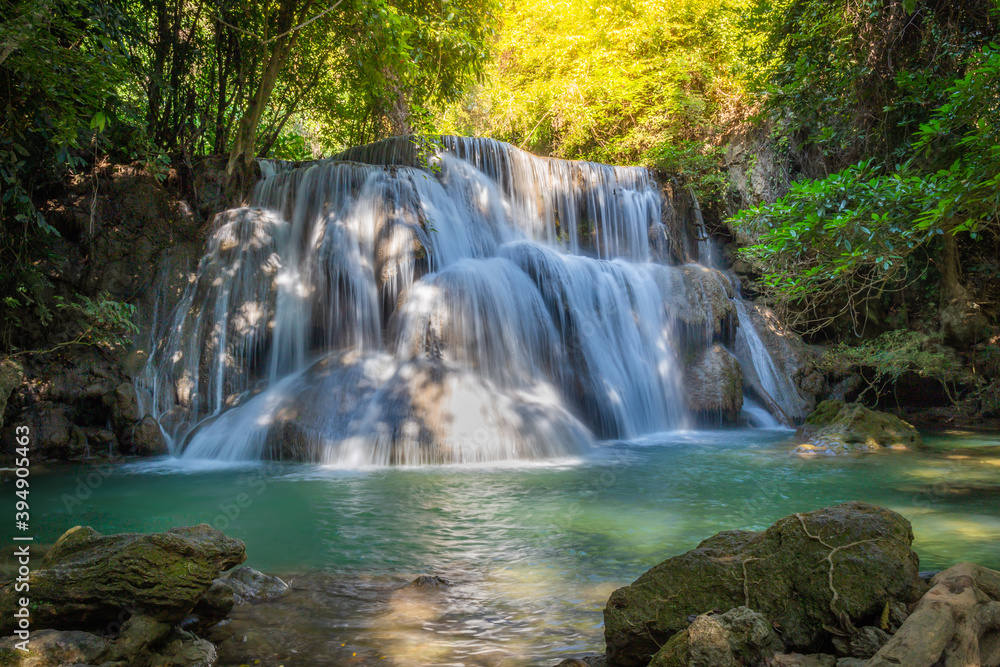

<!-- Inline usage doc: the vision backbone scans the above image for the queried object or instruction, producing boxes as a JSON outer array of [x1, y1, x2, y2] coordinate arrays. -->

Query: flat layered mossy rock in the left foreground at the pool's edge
[[0, 524, 246, 635]]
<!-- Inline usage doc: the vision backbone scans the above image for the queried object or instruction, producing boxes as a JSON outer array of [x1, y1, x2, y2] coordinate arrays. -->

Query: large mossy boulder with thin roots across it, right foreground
[[604, 502, 927, 667]]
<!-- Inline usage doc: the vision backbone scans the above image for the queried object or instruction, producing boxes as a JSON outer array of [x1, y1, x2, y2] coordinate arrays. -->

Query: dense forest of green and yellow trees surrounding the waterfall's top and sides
[[0, 0, 1000, 412]]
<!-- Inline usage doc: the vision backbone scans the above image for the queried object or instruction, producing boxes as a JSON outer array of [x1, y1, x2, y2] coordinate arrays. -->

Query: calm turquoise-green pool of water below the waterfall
[[5, 430, 1000, 667]]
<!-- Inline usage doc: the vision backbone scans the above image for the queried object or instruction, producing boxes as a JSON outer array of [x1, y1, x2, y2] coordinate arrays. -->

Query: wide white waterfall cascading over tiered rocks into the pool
[[138, 137, 804, 466]]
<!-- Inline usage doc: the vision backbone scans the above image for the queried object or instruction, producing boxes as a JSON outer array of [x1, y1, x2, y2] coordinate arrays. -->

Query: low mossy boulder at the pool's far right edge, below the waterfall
[[795, 400, 921, 454]]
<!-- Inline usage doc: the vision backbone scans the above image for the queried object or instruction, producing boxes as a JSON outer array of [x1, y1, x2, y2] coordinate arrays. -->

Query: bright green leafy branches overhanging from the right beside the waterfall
[[730, 47, 1000, 332]]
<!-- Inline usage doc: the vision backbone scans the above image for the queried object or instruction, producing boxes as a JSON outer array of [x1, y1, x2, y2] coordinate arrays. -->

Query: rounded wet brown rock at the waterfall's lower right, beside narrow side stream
[[684, 345, 743, 423]]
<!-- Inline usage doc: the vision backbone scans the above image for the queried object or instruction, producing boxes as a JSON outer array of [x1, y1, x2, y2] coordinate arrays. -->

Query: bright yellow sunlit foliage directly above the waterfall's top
[[440, 0, 749, 163]]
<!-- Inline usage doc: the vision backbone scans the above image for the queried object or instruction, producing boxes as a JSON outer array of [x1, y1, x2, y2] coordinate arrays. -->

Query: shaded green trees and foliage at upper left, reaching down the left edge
[[0, 0, 496, 354]]
